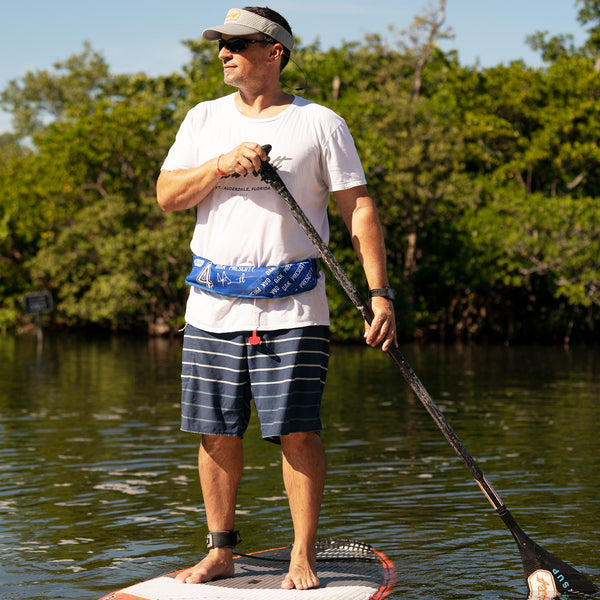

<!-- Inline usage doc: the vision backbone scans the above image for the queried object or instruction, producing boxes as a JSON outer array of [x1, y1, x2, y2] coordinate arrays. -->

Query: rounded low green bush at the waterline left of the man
[[27, 195, 193, 333]]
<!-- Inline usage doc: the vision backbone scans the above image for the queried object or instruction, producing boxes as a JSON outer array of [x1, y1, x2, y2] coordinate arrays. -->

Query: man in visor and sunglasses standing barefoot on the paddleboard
[[157, 7, 395, 589]]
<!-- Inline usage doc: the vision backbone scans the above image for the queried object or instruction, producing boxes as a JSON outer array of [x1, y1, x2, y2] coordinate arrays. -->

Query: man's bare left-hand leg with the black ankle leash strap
[[177, 435, 243, 583]]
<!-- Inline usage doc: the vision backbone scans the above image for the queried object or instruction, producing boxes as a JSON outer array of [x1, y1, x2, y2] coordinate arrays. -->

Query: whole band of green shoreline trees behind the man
[[0, 0, 600, 344]]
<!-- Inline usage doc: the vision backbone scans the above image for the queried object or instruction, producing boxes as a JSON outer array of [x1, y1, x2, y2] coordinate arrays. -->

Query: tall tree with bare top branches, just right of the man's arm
[[326, 2, 469, 334]]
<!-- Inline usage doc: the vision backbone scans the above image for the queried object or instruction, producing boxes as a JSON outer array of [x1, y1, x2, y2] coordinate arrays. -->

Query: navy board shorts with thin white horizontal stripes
[[181, 325, 329, 441]]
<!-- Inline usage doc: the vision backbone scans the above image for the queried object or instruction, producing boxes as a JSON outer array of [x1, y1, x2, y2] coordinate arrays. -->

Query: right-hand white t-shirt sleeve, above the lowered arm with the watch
[[323, 119, 367, 192]]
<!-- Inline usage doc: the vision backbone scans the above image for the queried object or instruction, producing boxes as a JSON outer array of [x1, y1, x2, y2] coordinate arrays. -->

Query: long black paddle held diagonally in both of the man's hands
[[259, 145, 598, 598]]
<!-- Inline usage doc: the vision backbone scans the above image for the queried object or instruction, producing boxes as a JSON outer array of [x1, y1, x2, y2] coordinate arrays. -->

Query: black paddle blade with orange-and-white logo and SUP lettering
[[497, 506, 598, 600]]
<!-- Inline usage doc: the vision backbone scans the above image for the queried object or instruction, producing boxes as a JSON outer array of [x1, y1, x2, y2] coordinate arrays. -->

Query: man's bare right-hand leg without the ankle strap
[[280, 433, 326, 590]]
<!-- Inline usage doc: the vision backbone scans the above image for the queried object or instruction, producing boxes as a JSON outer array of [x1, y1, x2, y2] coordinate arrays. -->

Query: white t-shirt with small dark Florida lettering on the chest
[[162, 94, 366, 332]]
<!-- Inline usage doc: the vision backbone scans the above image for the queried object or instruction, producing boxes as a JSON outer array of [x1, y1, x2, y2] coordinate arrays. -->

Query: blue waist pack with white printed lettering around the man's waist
[[185, 256, 319, 298]]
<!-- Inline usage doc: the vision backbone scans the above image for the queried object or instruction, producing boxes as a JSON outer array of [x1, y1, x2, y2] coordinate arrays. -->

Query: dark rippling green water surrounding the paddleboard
[[0, 335, 600, 600]]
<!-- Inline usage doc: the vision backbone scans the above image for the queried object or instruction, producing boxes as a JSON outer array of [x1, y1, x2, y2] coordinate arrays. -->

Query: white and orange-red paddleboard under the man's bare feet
[[100, 539, 396, 600]]
